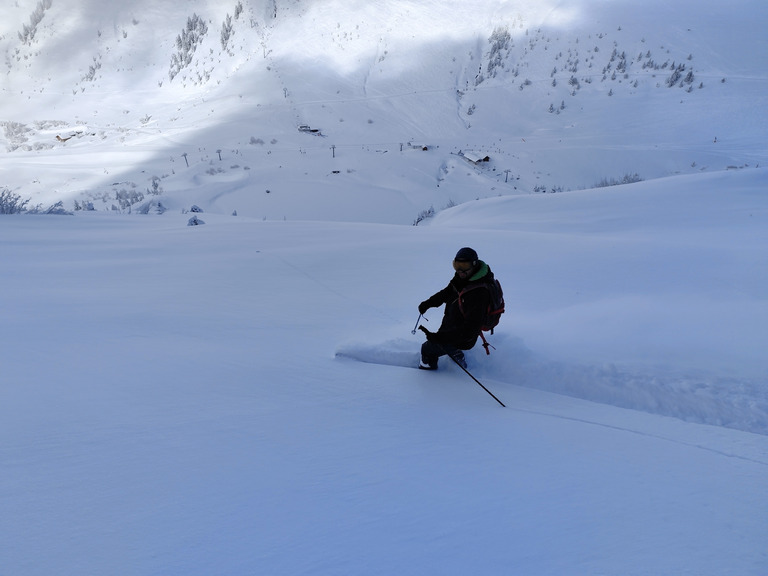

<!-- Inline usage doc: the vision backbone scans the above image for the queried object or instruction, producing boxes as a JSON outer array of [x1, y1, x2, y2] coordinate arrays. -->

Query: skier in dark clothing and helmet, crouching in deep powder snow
[[419, 247, 494, 370]]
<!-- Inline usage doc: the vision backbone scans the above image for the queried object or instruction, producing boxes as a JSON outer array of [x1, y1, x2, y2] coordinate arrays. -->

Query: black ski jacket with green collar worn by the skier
[[422, 260, 494, 350]]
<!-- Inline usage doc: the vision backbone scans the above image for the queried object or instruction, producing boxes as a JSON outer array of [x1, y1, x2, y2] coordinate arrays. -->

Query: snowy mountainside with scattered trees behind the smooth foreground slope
[[0, 0, 768, 223]]
